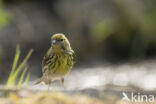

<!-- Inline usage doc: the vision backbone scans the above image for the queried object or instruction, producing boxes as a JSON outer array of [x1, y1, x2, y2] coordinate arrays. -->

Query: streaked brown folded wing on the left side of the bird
[[42, 47, 53, 73]]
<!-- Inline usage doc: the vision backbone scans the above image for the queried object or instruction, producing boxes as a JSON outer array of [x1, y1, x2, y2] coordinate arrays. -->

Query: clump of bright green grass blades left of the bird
[[6, 45, 33, 88]]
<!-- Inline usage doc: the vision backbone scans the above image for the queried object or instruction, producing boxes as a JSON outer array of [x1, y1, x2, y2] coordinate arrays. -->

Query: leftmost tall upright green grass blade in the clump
[[6, 45, 20, 86]]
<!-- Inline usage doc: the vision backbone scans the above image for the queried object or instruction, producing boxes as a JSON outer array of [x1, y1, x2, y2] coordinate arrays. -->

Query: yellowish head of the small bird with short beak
[[51, 33, 71, 53]]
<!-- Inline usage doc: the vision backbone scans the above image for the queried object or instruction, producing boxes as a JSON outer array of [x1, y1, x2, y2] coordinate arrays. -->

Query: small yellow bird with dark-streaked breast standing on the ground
[[34, 33, 75, 90]]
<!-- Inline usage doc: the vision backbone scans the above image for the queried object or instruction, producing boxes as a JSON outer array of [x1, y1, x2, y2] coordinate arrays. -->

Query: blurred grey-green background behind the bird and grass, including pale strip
[[0, 0, 156, 88]]
